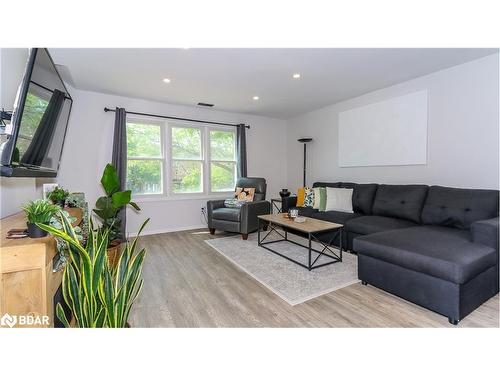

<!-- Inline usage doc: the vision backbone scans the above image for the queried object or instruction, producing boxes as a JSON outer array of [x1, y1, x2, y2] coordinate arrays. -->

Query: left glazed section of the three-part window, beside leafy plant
[[127, 121, 164, 195]]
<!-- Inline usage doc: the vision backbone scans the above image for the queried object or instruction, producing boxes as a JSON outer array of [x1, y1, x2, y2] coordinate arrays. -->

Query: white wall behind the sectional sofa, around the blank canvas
[[287, 54, 499, 189]]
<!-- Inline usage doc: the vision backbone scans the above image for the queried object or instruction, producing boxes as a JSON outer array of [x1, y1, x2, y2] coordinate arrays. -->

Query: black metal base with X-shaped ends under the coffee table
[[257, 218, 343, 271]]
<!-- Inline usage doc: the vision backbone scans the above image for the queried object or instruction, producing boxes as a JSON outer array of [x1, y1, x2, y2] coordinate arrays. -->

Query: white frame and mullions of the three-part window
[[127, 120, 237, 202]]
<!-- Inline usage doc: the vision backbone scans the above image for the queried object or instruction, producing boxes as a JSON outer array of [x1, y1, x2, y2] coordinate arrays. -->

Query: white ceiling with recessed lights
[[50, 48, 498, 118]]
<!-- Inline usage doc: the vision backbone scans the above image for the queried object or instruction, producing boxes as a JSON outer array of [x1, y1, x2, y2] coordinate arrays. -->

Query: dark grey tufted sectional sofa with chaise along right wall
[[283, 182, 499, 324]]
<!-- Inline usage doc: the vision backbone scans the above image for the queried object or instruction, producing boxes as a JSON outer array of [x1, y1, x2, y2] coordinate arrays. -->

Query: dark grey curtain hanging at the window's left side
[[111, 107, 127, 240]]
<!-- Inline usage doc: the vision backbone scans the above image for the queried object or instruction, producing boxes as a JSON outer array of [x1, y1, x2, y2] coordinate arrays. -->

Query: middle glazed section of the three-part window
[[171, 127, 203, 193]]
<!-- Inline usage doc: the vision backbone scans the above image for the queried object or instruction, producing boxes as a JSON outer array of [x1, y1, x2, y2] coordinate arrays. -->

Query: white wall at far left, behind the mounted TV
[[0, 48, 41, 218]]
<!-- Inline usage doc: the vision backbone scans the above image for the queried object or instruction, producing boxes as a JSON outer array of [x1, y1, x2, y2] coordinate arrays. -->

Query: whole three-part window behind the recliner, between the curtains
[[127, 119, 236, 196]]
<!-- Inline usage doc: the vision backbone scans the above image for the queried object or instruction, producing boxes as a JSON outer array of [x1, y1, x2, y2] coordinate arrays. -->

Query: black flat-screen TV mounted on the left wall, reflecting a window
[[2, 48, 73, 177]]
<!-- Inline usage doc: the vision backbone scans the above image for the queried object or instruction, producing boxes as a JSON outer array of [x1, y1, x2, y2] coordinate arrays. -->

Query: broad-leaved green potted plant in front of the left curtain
[[94, 164, 140, 264]]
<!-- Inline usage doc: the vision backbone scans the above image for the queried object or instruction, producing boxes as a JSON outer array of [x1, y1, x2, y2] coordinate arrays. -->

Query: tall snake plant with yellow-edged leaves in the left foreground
[[39, 215, 149, 328]]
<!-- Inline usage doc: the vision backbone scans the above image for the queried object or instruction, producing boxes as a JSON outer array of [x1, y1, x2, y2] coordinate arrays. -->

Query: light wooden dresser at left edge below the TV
[[0, 213, 62, 328]]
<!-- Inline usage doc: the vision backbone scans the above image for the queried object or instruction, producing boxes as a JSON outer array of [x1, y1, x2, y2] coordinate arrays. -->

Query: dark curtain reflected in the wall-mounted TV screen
[[21, 90, 65, 165]]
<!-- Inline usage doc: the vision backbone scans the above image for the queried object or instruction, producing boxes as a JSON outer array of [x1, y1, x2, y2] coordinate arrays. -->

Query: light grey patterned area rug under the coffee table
[[205, 233, 359, 305]]
